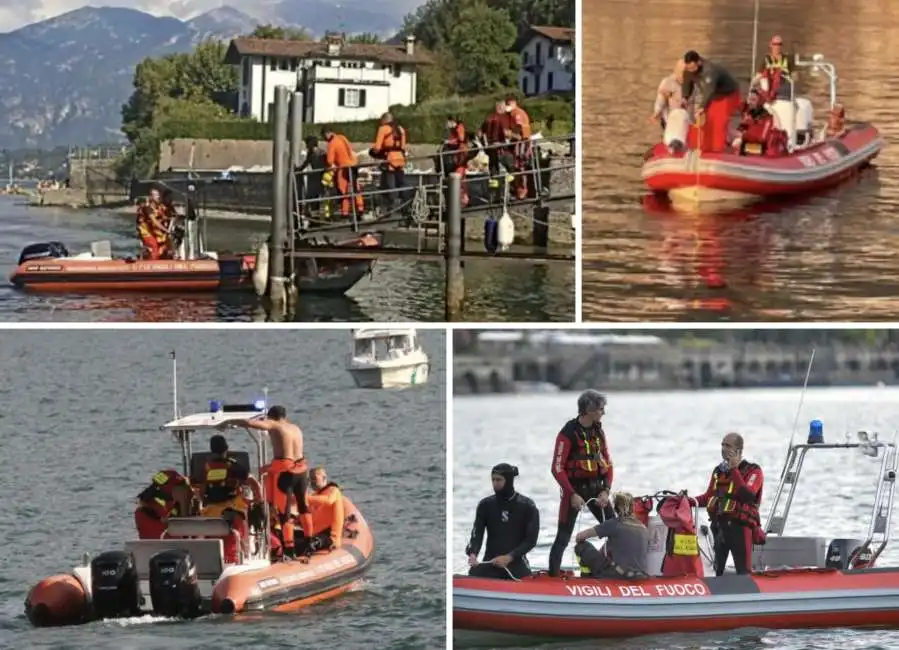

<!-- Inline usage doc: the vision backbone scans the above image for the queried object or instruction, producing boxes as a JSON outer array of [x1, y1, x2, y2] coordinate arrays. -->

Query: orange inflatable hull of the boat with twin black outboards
[[25, 497, 375, 627]]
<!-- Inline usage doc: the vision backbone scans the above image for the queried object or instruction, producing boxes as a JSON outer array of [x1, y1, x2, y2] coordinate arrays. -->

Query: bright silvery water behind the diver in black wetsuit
[[458, 388, 899, 650]]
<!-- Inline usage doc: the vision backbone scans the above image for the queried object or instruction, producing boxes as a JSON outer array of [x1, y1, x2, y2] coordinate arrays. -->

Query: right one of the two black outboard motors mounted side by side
[[150, 549, 202, 618]]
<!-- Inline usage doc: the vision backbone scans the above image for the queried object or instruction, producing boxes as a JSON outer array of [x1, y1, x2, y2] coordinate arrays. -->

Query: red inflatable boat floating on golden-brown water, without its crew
[[642, 55, 886, 203]]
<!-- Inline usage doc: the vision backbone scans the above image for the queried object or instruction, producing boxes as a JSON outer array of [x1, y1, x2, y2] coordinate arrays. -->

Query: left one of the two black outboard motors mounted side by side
[[91, 551, 141, 618]]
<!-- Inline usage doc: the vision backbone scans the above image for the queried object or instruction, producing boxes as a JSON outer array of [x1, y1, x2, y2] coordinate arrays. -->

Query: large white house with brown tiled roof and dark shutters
[[225, 34, 432, 123]]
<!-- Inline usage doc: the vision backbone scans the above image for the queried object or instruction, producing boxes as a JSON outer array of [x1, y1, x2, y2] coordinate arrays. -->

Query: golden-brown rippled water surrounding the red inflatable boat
[[583, 0, 899, 321]]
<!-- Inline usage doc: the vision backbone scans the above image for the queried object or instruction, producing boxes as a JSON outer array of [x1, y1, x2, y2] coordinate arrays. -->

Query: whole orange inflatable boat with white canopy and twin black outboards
[[25, 352, 375, 627]]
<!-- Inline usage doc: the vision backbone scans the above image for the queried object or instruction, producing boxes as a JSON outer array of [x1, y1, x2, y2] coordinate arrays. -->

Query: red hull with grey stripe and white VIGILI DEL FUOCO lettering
[[453, 568, 899, 639]]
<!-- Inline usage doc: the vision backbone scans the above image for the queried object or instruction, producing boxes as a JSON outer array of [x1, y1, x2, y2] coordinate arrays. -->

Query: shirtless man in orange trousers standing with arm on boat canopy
[[225, 406, 312, 557]]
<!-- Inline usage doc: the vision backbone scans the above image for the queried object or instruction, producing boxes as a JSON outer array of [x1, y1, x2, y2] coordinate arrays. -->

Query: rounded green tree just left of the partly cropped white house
[[447, 0, 518, 95]]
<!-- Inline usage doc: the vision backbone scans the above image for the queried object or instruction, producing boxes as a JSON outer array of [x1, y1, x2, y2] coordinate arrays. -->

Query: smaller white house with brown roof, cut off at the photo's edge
[[515, 25, 574, 95]]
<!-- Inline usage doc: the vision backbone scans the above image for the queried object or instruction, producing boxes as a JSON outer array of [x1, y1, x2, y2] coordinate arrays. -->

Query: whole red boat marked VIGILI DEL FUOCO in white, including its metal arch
[[453, 421, 899, 647]]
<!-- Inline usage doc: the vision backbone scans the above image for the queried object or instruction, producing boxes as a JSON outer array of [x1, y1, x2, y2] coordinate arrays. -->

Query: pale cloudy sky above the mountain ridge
[[0, 0, 425, 32]]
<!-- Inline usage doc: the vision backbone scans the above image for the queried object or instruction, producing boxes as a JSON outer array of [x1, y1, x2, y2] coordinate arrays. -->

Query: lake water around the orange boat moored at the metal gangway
[[0, 197, 575, 322]]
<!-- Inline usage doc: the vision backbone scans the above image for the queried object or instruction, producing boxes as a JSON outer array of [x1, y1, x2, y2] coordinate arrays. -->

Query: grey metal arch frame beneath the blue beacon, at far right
[[765, 431, 899, 564]]
